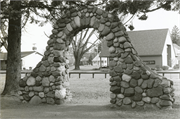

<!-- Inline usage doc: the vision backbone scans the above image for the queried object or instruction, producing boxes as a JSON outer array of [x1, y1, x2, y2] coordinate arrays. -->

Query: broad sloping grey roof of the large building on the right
[[100, 29, 168, 57]]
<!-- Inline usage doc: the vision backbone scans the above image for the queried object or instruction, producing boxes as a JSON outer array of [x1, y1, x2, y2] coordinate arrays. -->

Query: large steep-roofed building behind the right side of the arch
[[100, 29, 178, 68]]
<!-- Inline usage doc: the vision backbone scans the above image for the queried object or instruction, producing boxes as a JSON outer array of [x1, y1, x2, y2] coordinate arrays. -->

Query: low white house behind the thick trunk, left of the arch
[[0, 51, 43, 70]]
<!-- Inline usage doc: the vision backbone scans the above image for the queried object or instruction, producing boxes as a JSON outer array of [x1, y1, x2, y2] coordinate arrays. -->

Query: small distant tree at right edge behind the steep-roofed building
[[171, 25, 180, 46]]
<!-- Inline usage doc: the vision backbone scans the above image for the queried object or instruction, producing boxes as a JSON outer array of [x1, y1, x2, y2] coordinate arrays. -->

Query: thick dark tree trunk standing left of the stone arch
[[2, 1, 21, 95]]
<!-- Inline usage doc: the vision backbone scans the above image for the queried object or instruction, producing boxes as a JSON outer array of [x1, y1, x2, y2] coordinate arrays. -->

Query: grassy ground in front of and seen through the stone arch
[[0, 68, 180, 119]]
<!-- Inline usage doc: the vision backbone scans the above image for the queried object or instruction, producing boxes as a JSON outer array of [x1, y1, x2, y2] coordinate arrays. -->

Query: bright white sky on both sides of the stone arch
[[2, 9, 180, 53]]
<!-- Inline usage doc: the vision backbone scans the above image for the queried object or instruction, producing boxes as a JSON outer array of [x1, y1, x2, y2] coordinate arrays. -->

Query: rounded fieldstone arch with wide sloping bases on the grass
[[19, 6, 174, 108]]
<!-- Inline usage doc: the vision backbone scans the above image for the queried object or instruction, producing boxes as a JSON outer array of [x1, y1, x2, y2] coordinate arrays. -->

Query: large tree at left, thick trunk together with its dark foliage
[[0, 0, 52, 95]]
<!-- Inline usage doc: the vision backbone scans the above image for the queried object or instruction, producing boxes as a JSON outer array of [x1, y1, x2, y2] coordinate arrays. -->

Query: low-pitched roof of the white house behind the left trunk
[[0, 51, 43, 60]]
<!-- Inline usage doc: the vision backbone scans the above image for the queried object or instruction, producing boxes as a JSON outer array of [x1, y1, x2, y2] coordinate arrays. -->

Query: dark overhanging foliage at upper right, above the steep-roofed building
[[105, 0, 180, 30]]
